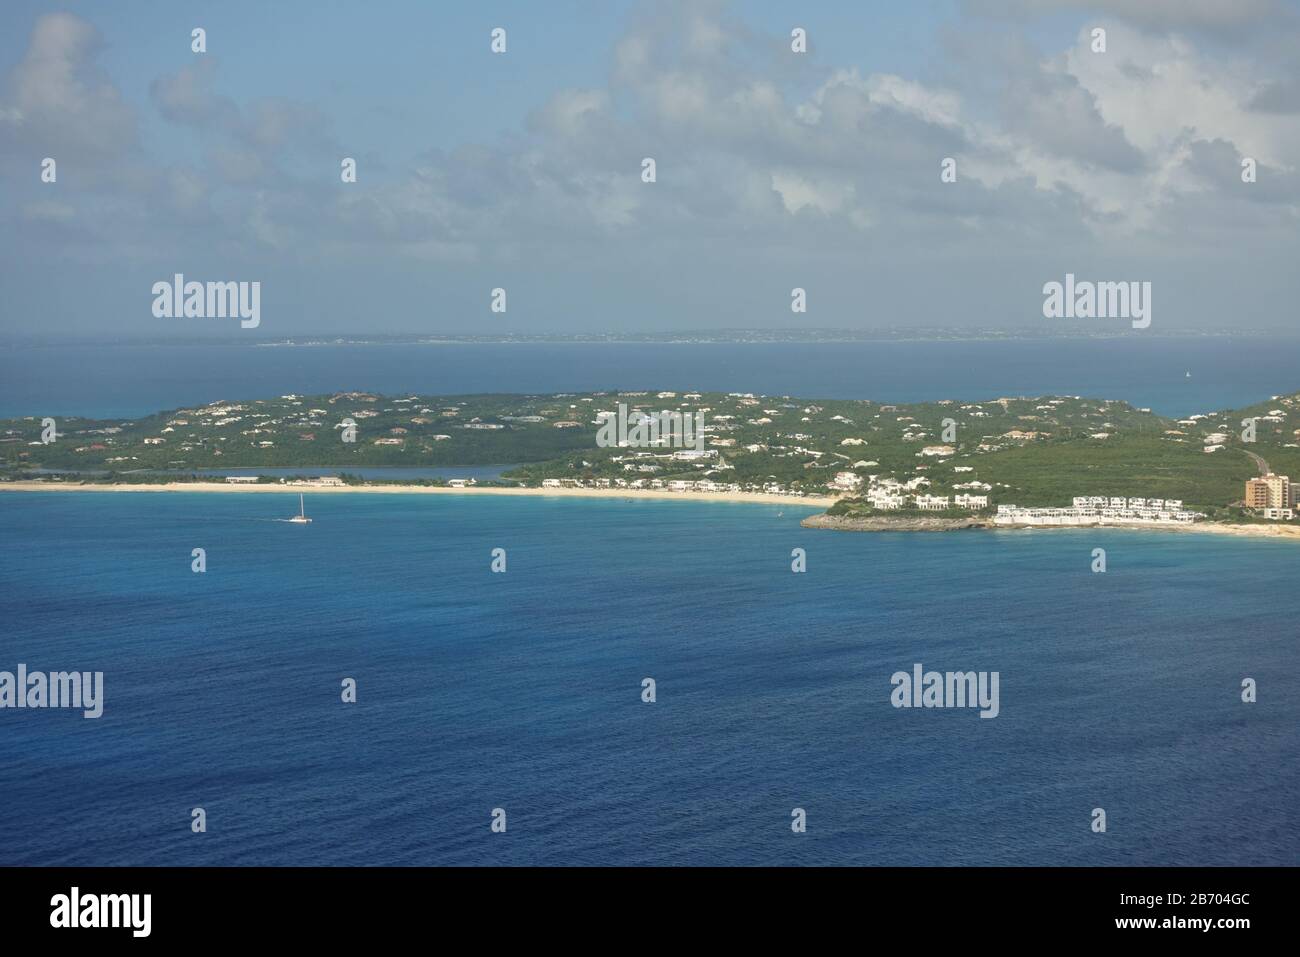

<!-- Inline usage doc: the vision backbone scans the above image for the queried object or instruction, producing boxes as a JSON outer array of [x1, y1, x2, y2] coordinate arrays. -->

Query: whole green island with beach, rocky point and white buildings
[[0, 390, 1300, 532]]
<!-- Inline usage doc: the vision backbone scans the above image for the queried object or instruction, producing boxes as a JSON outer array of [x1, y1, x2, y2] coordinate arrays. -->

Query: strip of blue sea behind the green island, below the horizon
[[0, 335, 1300, 417]]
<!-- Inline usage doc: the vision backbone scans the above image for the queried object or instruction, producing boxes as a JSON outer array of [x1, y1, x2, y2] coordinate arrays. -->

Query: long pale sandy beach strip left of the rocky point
[[0, 481, 839, 508]]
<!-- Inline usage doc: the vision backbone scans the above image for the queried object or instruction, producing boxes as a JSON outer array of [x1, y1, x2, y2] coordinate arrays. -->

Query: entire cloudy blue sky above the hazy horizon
[[0, 0, 1300, 339]]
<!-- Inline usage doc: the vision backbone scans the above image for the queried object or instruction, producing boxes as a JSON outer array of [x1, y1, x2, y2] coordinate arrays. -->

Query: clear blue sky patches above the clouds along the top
[[0, 0, 972, 174]]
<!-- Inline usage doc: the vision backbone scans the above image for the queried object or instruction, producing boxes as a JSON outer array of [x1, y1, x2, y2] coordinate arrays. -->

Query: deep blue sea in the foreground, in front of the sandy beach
[[0, 493, 1300, 865]]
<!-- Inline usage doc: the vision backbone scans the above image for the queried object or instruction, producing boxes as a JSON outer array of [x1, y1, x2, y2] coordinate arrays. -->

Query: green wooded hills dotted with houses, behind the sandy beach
[[0, 391, 1300, 520]]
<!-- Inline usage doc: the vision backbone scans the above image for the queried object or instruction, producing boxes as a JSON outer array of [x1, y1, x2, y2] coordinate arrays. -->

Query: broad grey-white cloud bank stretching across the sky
[[0, 0, 1300, 332]]
